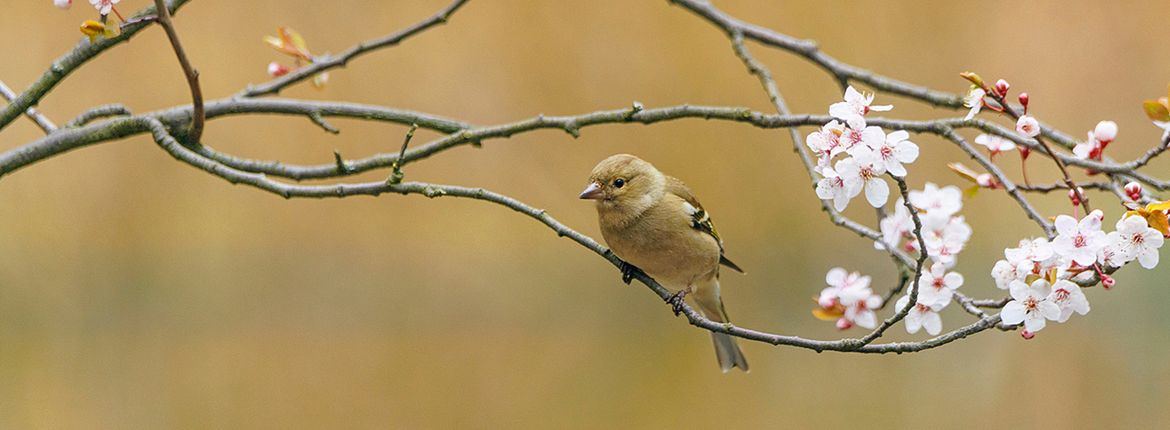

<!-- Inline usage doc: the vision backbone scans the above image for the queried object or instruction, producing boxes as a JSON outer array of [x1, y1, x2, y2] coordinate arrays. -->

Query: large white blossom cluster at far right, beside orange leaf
[[991, 206, 1165, 338]]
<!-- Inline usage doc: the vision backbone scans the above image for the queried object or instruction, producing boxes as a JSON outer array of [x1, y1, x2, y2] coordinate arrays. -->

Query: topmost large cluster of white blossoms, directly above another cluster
[[807, 86, 918, 211]]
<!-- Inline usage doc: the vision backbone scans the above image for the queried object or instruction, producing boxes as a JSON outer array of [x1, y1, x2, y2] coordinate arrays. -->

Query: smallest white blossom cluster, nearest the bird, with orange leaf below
[[812, 268, 882, 330]]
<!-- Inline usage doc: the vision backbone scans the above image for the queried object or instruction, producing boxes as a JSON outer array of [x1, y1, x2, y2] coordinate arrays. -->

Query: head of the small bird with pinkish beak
[[580, 154, 666, 215]]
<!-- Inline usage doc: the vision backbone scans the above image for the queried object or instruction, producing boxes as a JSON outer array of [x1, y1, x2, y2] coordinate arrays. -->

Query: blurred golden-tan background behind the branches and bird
[[0, 0, 1170, 429]]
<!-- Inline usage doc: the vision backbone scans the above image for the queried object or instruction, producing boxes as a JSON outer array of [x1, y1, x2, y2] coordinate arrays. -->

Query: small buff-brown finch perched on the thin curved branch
[[580, 154, 748, 373]]
